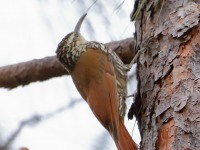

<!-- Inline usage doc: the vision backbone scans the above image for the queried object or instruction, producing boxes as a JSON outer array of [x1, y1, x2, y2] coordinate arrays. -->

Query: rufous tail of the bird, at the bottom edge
[[116, 120, 138, 150]]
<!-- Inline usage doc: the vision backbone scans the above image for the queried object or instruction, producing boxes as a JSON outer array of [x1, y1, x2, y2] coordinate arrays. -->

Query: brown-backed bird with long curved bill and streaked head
[[56, 13, 138, 150]]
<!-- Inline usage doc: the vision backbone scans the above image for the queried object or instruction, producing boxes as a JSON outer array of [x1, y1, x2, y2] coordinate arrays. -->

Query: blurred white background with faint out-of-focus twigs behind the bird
[[0, 0, 140, 150]]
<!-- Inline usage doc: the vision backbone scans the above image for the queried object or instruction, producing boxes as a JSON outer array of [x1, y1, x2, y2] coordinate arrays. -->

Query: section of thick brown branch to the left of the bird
[[0, 56, 67, 89]]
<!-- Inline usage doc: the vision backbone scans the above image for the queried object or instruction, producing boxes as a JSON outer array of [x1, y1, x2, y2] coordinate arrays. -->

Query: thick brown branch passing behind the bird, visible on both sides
[[0, 38, 135, 89]]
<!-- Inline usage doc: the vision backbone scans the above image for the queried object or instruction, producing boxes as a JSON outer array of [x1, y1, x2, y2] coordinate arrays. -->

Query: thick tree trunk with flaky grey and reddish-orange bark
[[129, 0, 200, 150]]
